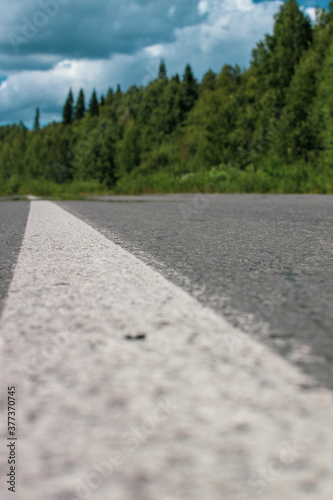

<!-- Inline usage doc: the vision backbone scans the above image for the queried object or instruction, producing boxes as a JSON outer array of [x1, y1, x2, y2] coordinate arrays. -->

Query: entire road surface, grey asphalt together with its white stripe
[[0, 195, 333, 500]]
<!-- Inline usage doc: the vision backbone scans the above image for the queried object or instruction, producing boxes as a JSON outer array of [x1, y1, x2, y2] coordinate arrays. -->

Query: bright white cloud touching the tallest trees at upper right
[[145, 0, 282, 77]]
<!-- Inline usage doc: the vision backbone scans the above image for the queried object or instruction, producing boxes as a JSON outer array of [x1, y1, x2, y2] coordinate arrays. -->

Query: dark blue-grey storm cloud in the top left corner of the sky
[[0, 0, 203, 70]]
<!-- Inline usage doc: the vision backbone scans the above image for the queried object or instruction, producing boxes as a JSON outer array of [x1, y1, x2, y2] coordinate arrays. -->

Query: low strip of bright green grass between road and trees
[[0, 162, 333, 200]]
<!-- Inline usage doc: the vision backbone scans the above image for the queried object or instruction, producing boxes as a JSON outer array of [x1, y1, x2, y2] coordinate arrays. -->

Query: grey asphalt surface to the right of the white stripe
[[59, 194, 333, 389]]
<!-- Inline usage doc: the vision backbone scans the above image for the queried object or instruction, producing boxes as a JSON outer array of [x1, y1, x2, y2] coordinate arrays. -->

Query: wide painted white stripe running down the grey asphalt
[[0, 201, 333, 500]]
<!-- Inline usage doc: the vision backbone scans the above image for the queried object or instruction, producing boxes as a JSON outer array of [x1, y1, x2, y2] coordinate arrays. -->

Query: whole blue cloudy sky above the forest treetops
[[0, 0, 328, 125]]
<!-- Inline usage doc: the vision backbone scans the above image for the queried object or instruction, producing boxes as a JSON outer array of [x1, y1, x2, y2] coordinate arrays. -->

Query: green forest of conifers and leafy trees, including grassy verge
[[0, 0, 333, 195]]
